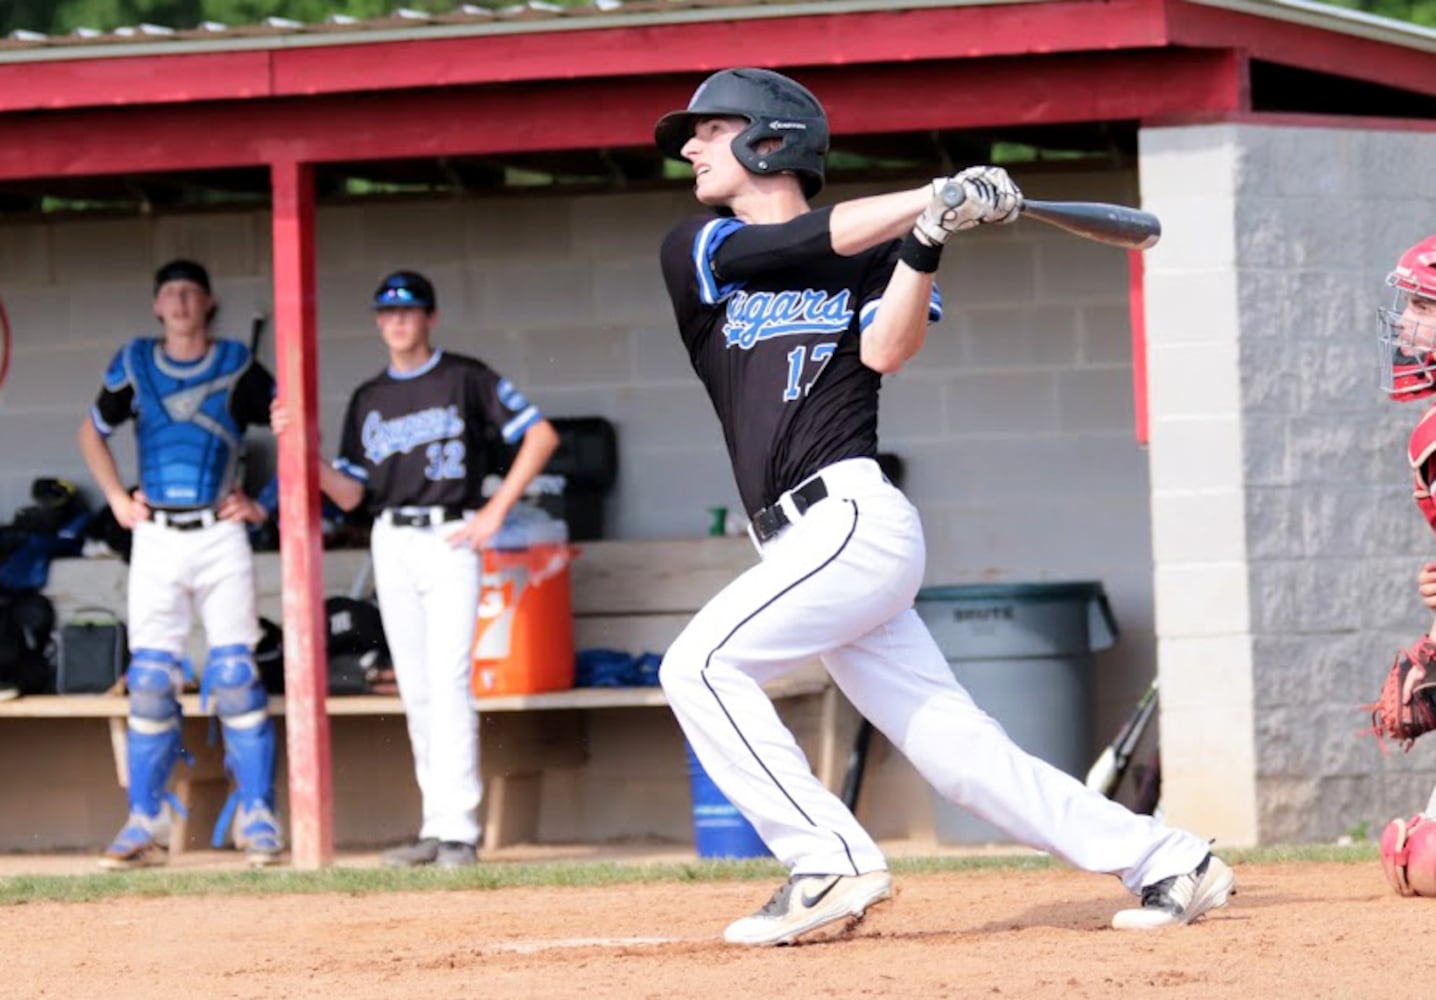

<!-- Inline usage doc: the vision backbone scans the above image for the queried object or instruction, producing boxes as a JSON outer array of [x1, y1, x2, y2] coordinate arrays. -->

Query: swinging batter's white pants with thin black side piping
[[661, 458, 1208, 892]]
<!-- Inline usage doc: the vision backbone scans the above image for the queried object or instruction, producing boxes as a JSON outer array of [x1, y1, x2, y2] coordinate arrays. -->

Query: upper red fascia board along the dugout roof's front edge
[[0, 0, 1167, 111]]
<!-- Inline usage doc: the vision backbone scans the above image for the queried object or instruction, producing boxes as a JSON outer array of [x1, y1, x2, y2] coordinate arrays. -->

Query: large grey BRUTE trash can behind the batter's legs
[[916, 580, 1117, 843]]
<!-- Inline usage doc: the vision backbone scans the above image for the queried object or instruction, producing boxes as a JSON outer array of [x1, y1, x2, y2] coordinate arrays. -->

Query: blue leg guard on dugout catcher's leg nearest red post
[[204, 645, 281, 864]]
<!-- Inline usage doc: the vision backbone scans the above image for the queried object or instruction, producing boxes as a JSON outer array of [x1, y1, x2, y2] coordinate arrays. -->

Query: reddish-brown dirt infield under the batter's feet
[[0, 862, 1407, 1000]]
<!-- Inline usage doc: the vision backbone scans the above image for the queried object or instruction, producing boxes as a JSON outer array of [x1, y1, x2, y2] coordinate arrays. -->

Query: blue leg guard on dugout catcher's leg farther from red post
[[125, 649, 184, 818]]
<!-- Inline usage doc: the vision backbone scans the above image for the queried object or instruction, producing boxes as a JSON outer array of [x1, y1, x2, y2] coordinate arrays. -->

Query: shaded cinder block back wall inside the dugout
[[0, 171, 1155, 833]]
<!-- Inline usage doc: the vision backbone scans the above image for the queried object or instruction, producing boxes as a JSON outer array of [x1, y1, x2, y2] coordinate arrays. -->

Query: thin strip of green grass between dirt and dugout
[[0, 842, 1379, 905]]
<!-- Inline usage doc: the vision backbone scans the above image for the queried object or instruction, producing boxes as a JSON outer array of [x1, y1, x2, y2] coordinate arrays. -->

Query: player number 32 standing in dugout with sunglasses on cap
[[274, 272, 559, 868]]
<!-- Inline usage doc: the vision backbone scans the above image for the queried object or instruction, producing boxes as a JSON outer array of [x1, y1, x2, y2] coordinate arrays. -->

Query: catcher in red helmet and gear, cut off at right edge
[[1370, 236, 1436, 897]]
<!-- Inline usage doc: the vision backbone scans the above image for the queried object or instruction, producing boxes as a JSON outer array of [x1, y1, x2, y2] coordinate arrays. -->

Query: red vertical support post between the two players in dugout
[[270, 161, 335, 869]]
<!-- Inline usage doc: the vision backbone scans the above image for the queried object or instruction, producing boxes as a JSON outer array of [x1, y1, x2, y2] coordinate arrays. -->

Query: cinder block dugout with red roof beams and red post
[[0, 0, 1436, 861]]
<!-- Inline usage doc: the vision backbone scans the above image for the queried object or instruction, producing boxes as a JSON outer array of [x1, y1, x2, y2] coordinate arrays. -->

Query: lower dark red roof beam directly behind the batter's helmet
[[0, 52, 1242, 180]]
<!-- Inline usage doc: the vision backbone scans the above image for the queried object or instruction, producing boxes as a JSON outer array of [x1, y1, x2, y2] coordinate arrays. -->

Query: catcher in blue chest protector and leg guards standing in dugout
[[79, 260, 281, 868]]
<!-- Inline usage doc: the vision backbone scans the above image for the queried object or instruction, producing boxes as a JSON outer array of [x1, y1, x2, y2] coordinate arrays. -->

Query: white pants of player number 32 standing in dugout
[[370, 520, 482, 843]]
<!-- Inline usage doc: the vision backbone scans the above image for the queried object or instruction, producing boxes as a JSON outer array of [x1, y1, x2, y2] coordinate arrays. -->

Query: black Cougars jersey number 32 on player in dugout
[[335, 351, 543, 511]]
